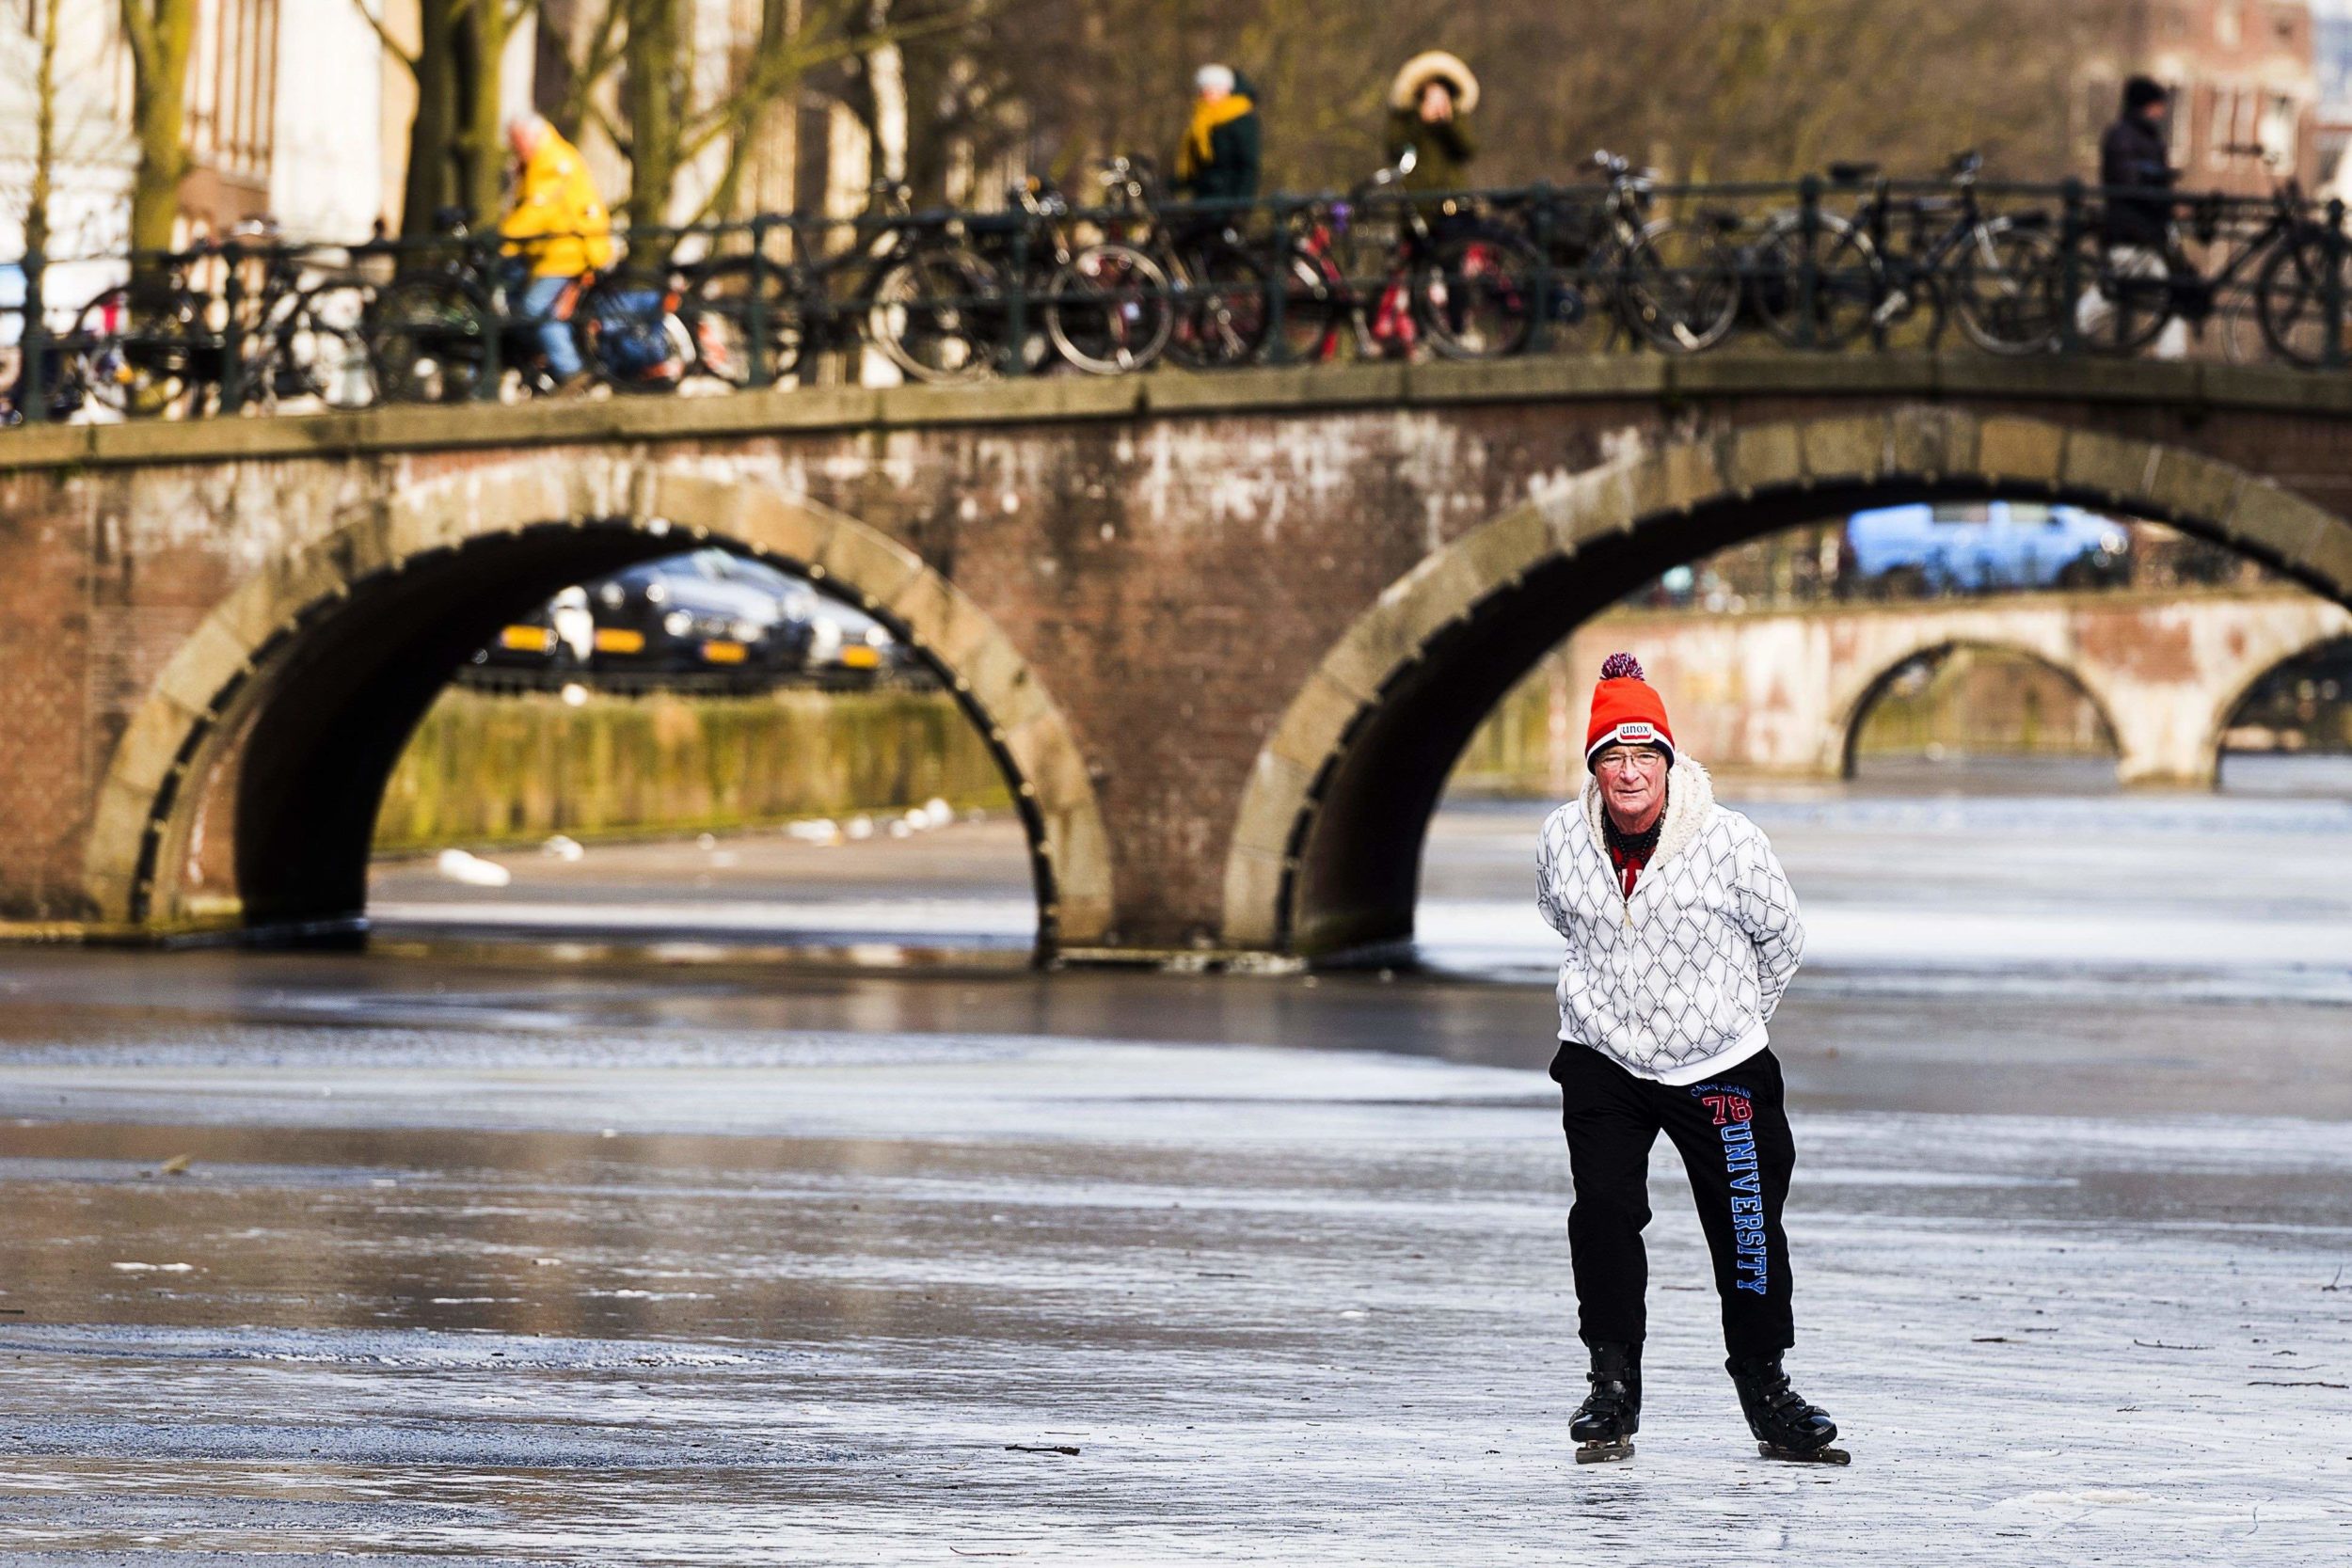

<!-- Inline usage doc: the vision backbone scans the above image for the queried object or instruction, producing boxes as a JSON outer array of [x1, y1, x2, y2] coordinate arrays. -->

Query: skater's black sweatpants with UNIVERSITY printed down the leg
[[1552, 1044, 1797, 1359]]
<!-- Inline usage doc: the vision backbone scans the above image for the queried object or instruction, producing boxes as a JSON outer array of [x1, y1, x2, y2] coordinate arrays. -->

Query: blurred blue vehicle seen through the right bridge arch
[[1847, 500, 2131, 593]]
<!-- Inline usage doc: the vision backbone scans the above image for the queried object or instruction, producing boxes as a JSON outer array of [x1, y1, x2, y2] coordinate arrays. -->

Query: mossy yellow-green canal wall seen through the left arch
[[376, 687, 1009, 853]]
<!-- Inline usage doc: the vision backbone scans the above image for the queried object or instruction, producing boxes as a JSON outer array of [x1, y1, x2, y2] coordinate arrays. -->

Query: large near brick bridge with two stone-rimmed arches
[[0, 355, 2352, 957]]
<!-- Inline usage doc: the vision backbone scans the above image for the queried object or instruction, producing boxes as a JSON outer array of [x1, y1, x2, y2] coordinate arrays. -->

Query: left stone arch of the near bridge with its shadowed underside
[[83, 453, 1110, 950]]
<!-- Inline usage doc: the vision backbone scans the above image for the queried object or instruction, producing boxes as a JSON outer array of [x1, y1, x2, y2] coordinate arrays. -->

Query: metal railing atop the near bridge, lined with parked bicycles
[[0, 155, 2352, 423]]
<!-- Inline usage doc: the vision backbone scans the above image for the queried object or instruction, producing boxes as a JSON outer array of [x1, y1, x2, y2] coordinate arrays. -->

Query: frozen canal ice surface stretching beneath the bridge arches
[[0, 797, 2352, 1568]]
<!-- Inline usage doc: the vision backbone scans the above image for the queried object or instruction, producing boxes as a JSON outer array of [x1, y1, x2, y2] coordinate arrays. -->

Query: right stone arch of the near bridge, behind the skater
[[1223, 402, 2352, 955]]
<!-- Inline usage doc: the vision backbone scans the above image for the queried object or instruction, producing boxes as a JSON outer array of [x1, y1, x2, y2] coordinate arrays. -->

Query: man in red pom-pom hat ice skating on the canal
[[1536, 654, 1849, 1465]]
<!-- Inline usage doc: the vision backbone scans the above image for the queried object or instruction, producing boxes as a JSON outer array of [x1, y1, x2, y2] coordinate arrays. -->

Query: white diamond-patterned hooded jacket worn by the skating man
[[1536, 757, 1804, 1084]]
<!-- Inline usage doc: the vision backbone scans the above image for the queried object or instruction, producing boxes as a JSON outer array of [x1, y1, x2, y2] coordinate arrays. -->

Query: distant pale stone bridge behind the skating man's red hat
[[1566, 588, 2352, 787]]
